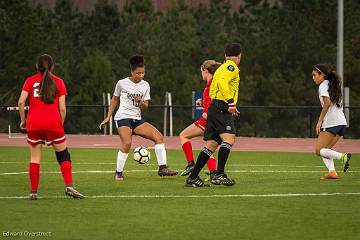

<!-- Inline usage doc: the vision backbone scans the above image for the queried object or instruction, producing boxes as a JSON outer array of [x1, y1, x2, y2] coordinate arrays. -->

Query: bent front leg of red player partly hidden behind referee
[[179, 123, 204, 176]]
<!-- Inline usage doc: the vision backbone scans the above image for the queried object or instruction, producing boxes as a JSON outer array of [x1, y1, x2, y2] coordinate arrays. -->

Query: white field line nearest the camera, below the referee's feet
[[0, 192, 360, 199]]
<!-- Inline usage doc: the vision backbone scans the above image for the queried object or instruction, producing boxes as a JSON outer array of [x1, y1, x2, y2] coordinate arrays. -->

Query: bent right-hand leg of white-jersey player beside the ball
[[133, 122, 178, 176]]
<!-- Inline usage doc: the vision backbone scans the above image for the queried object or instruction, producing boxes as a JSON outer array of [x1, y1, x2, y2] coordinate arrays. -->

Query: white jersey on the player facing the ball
[[114, 77, 150, 120]]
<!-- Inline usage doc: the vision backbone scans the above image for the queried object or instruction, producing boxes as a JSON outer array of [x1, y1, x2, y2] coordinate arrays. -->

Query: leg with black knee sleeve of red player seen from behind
[[52, 139, 84, 199]]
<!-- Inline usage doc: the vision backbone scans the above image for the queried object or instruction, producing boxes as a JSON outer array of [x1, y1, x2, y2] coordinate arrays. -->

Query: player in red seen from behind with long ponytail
[[18, 54, 83, 200]]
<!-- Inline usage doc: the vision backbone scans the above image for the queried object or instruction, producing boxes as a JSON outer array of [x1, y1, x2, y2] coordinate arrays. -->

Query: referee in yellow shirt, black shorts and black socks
[[185, 43, 241, 187]]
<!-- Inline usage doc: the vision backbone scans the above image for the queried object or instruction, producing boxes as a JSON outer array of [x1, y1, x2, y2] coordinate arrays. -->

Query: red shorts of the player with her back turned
[[28, 130, 66, 146]]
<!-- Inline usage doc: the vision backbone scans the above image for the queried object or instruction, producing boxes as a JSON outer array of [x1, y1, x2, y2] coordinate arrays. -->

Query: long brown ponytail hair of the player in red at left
[[37, 54, 58, 104]]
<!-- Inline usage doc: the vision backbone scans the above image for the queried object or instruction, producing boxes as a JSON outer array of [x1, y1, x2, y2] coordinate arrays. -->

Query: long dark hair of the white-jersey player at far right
[[313, 64, 342, 107]]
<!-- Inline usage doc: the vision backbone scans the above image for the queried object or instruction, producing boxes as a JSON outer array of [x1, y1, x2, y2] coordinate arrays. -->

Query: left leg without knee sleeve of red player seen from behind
[[29, 144, 42, 200]]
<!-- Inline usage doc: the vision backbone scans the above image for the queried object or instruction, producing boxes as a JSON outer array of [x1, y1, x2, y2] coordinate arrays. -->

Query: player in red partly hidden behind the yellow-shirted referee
[[179, 60, 221, 178]]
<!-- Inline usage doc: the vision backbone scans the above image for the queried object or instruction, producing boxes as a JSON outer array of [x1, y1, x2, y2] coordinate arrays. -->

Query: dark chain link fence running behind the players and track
[[0, 105, 360, 138]]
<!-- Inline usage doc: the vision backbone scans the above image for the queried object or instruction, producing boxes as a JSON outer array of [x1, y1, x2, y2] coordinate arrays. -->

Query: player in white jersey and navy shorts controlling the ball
[[99, 55, 177, 180]]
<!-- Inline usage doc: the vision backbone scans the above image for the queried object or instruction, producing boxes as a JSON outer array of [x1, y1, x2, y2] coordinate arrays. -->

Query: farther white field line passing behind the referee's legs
[[0, 169, 359, 176]]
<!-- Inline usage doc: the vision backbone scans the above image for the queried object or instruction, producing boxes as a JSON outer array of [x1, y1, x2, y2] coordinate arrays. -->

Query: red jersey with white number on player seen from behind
[[22, 73, 67, 131]]
